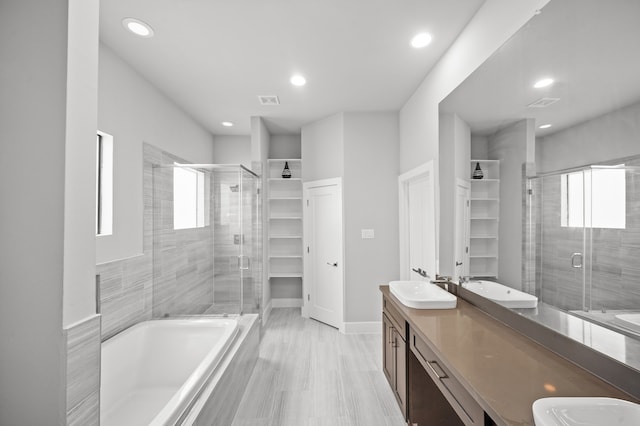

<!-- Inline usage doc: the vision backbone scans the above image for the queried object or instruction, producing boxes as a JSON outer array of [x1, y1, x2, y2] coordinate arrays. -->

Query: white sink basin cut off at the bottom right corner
[[532, 397, 640, 426]]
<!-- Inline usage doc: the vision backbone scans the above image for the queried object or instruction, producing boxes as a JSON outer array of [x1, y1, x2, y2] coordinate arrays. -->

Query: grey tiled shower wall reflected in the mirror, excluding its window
[[525, 162, 640, 310]]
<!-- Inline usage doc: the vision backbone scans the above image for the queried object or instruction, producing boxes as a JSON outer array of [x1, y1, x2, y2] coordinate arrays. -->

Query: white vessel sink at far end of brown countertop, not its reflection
[[389, 281, 457, 309]]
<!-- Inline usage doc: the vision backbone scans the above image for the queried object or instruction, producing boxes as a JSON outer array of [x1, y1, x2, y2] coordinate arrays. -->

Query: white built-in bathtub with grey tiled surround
[[100, 318, 238, 426]]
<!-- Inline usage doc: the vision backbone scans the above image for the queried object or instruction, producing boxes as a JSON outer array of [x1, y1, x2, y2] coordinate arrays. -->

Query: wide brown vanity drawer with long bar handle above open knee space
[[410, 330, 484, 425]]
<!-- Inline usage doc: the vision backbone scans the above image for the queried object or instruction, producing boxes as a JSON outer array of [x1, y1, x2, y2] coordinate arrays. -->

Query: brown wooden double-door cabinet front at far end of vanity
[[382, 299, 407, 418]]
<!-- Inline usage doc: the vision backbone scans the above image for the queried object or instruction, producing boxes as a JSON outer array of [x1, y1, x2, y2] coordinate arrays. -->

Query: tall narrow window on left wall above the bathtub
[[96, 132, 113, 235]]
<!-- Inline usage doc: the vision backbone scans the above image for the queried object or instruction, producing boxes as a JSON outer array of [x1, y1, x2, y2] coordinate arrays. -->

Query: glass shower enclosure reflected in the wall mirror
[[524, 160, 640, 335]]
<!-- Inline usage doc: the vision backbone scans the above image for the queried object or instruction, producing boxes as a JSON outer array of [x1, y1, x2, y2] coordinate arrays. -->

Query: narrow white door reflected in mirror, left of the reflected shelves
[[453, 179, 471, 280]]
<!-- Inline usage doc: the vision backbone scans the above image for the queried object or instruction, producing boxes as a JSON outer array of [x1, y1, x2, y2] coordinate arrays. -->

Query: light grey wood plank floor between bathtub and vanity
[[233, 309, 405, 426]]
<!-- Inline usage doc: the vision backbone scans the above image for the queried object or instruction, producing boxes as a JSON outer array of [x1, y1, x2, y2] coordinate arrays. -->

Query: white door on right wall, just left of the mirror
[[398, 162, 437, 280]]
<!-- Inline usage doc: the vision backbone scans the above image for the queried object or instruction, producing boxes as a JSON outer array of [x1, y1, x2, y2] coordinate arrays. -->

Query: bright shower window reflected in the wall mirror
[[560, 165, 626, 229]]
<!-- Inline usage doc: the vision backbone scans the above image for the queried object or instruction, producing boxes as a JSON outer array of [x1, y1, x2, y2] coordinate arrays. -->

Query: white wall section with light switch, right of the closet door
[[342, 112, 399, 322]]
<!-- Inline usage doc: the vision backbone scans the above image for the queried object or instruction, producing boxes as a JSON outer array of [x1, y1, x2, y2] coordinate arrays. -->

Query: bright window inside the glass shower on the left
[[173, 167, 208, 229]]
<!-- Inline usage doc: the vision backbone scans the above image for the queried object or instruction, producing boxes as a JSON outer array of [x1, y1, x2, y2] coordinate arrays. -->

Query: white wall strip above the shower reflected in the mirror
[[536, 102, 640, 173]]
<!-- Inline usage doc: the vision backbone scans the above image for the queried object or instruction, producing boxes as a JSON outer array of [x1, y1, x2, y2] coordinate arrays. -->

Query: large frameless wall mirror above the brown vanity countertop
[[440, 0, 640, 371]]
